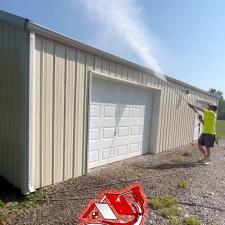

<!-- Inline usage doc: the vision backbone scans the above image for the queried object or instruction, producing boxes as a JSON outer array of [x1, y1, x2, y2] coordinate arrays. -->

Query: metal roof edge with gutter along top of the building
[[0, 10, 217, 98]]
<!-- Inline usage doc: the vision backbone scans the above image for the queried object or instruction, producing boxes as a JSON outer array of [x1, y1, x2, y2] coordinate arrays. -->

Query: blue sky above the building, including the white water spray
[[0, 0, 225, 95]]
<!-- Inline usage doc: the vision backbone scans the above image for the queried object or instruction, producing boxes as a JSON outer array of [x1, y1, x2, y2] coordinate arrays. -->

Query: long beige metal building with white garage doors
[[0, 11, 216, 194]]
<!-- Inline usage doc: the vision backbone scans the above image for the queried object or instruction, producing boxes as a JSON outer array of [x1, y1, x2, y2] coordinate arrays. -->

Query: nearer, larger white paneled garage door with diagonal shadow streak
[[88, 78, 153, 168]]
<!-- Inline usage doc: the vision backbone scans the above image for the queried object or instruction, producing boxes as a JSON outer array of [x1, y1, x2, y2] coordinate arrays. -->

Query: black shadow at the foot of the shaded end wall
[[0, 176, 25, 203]]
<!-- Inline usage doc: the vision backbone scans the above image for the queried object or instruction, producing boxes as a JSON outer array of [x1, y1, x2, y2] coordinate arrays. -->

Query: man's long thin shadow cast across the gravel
[[138, 162, 203, 170]]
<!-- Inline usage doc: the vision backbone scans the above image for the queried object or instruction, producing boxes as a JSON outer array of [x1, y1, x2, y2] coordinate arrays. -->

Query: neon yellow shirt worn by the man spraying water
[[202, 109, 217, 134]]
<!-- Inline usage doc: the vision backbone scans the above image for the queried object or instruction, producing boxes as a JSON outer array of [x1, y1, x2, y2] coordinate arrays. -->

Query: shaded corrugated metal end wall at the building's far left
[[0, 21, 28, 190]]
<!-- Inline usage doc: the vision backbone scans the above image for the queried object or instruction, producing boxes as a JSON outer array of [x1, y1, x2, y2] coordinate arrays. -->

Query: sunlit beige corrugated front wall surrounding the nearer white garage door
[[35, 35, 215, 188]]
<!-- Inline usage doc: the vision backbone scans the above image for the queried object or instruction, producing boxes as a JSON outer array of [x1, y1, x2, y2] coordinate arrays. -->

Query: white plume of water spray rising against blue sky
[[74, 0, 162, 78]]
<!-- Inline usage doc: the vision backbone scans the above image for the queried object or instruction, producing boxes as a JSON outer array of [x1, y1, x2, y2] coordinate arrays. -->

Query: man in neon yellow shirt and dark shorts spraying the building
[[188, 104, 217, 165]]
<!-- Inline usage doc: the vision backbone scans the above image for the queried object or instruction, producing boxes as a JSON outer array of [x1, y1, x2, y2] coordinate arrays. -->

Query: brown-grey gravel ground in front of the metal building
[[3, 141, 225, 225]]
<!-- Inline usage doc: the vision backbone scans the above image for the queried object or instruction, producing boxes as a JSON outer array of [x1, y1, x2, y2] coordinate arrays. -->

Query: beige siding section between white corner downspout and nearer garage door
[[34, 35, 87, 188]]
